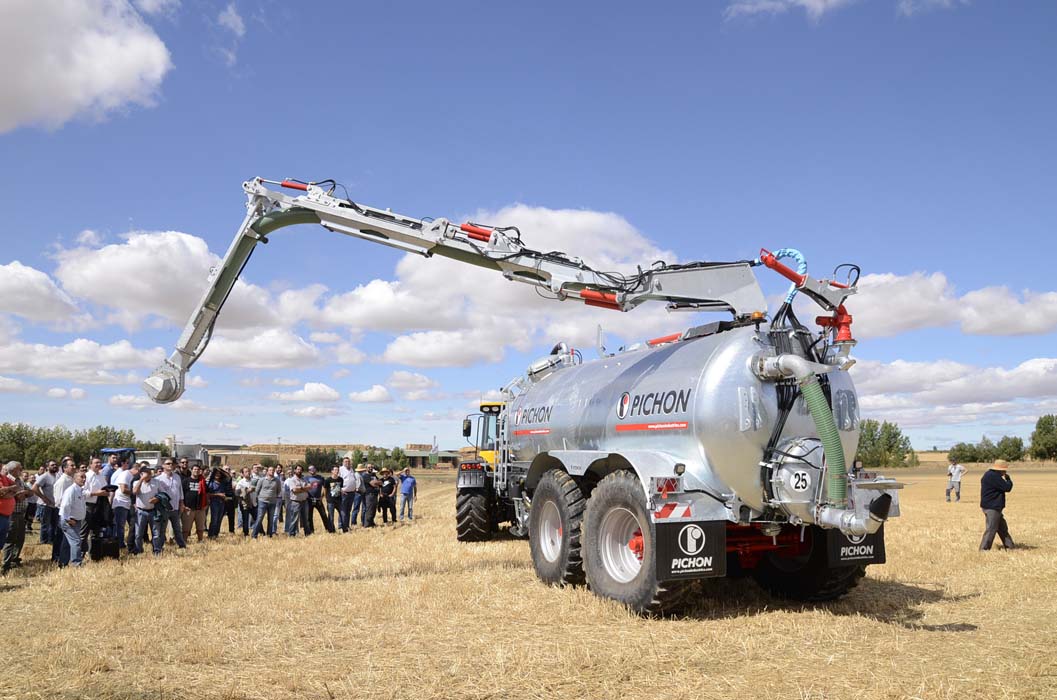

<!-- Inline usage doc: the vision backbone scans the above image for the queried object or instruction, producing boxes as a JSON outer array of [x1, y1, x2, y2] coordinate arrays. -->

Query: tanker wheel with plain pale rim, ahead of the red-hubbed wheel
[[529, 469, 585, 586]]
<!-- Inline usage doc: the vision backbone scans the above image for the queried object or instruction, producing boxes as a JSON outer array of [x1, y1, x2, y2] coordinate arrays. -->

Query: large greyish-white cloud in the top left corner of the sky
[[0, 0, 172, 133]]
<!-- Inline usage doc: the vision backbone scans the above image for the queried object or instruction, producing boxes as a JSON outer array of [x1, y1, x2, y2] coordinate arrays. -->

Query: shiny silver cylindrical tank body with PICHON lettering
[[507, 327, 858, 510]]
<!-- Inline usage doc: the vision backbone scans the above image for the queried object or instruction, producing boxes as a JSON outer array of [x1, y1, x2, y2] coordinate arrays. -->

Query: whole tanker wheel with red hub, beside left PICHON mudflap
[[583, 472, 692, 613]]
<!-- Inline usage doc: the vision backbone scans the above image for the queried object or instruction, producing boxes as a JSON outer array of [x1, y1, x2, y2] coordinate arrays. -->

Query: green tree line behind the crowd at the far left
[[0, 423, 169, 469]]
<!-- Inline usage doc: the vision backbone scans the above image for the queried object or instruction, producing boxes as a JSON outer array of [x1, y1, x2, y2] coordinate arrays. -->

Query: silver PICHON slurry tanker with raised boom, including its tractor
[[144, 178, 902, 612]]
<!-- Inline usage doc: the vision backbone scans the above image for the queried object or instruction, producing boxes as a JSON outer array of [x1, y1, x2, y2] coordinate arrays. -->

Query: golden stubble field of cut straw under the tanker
[[0, 465, 1057, 700]]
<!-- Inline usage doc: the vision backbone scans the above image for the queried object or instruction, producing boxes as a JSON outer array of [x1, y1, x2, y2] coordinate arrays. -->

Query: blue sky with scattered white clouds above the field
[[0, 0, 1057, 447]]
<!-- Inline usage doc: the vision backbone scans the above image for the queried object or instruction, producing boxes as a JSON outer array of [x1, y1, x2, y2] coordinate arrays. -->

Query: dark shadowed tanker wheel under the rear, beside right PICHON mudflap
[[753, 526, 866, 603]]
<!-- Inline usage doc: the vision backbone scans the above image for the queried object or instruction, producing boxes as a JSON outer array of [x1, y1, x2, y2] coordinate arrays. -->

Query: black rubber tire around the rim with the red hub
[[583, 471, 694, 614]]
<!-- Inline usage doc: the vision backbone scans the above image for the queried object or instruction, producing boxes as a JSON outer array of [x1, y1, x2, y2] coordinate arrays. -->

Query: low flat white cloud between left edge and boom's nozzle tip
[[0, 338, 165, 384]]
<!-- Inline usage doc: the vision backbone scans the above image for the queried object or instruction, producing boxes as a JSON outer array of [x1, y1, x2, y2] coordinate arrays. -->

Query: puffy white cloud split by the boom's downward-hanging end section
[[55, 231, 280, 333]]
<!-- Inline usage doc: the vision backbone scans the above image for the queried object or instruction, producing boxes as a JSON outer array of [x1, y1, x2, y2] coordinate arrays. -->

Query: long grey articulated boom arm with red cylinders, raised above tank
[[144, 178, 850, 403]]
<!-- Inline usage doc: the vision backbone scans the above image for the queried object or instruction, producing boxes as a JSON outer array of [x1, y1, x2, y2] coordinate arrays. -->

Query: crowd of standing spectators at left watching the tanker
[[0, 455, 418, 574]]
